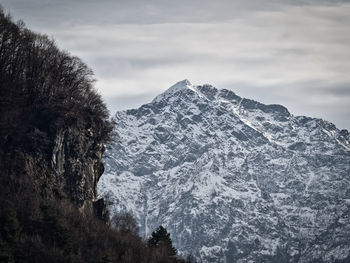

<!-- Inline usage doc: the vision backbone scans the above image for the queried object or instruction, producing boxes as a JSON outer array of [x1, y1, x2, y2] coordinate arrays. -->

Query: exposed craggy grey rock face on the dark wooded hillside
[[50, 128, 104, 214]]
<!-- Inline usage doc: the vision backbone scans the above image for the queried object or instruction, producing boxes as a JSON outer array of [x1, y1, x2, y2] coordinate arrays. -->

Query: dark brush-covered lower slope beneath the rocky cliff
[[0, 194, 194, 263]]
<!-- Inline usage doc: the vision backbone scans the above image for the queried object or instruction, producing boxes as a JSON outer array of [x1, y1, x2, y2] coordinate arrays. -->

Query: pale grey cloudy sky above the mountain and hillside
[[0, 0, 350, 130]]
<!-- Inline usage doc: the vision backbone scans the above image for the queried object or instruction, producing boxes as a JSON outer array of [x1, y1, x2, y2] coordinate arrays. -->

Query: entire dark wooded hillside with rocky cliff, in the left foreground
[[0, 7, 190, 263]]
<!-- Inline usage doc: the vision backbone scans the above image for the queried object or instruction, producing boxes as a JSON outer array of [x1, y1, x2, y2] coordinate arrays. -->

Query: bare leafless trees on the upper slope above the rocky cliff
[[0, 8, 112, 144]]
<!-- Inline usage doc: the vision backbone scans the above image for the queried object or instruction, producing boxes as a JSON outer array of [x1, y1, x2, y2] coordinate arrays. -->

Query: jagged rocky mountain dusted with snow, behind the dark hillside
[[99, 80, 350, 262]]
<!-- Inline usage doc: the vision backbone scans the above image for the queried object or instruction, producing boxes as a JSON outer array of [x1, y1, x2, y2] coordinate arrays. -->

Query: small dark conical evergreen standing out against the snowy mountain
[[148, 226, 177, 256]]
